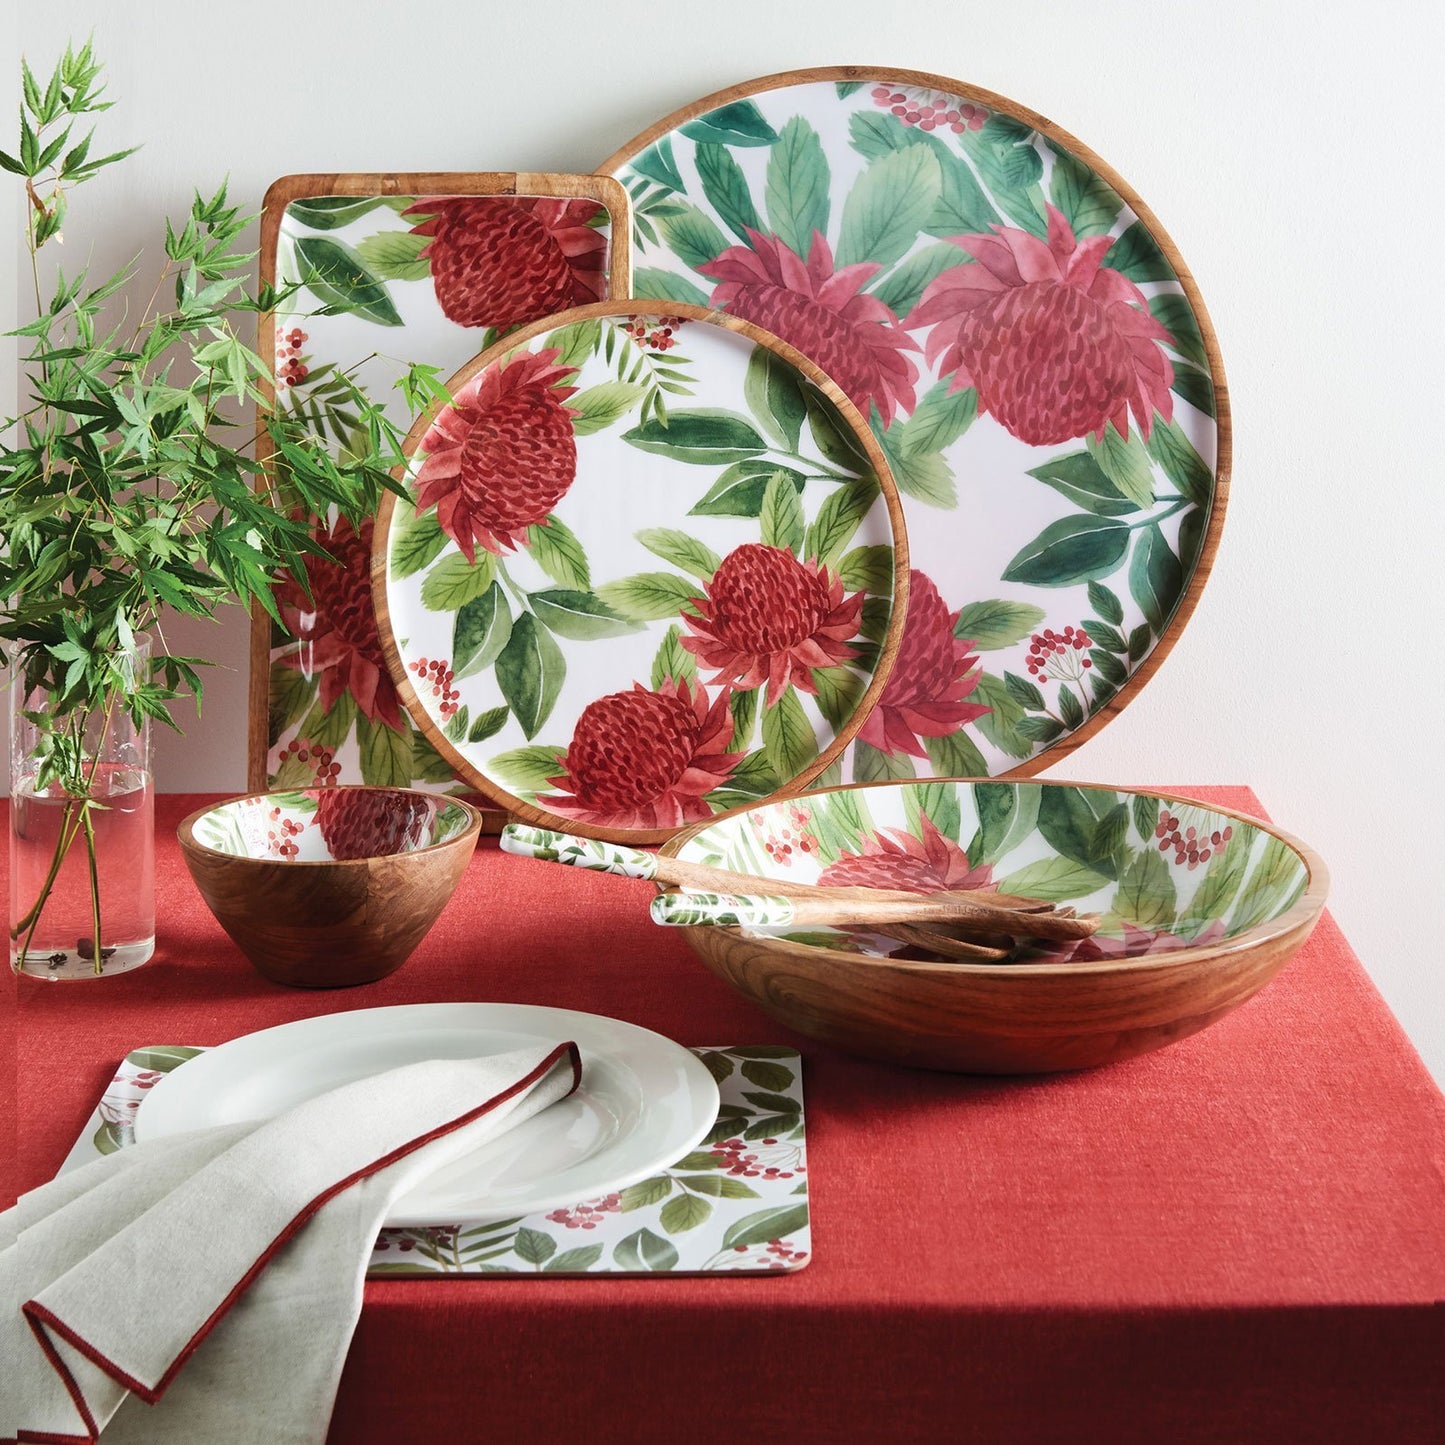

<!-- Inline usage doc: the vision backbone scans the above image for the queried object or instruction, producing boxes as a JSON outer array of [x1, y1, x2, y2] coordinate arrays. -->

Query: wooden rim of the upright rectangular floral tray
[[246, 171, 631, 792]]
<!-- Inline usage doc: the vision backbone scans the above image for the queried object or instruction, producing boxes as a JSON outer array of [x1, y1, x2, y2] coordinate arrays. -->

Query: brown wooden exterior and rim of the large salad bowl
[[662, 779, 1329, 1074]]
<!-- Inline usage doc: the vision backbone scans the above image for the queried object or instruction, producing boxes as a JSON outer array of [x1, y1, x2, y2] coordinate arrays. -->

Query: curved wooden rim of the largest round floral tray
[[597, 65, 1233, 780]]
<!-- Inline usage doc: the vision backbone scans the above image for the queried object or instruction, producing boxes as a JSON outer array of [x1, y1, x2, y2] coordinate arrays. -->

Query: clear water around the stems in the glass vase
[[10, 763, 156, 978]]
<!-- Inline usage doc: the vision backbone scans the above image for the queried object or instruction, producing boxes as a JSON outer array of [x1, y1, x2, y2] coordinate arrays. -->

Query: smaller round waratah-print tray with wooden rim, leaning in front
[[373, 302, 907, 842]]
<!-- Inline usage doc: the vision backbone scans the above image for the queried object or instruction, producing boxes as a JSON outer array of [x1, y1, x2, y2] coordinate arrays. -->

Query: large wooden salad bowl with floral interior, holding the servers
[[662, 779, 1328, 1074]]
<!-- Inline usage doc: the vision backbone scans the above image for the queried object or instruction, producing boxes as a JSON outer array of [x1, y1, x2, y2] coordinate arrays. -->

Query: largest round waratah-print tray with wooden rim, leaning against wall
[[600, 66, 1230, 782]]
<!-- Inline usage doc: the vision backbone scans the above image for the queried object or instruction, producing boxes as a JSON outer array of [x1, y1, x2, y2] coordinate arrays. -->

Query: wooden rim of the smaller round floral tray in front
[[371, 299, 909, 845]]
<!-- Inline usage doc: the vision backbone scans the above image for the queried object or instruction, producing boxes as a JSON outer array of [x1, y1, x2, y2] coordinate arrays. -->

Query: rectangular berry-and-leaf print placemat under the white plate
[[61, 1045, 812, 1276]]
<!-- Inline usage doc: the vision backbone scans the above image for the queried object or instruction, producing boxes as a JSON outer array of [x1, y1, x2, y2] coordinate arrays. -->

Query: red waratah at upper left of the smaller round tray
[[416, 347, 577, 556]]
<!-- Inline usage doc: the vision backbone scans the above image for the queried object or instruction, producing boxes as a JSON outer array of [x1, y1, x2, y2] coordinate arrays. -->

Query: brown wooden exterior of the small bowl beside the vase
[[176, 793, 483, 988]]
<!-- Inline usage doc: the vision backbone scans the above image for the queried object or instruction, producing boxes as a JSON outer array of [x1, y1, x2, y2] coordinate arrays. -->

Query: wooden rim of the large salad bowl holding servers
[[657, 777, 1329, 980]]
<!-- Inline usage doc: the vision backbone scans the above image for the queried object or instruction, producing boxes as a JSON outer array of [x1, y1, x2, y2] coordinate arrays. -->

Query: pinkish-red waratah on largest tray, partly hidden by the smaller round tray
[[698, 228, 918, 426]]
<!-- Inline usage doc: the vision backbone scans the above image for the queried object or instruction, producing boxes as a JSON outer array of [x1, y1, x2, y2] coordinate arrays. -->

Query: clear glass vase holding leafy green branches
[[9, 640, 156, 980]]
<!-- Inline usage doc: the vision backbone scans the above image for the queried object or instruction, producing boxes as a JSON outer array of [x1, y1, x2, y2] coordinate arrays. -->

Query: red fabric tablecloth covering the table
[[0, 788, 1445, 1445]]
